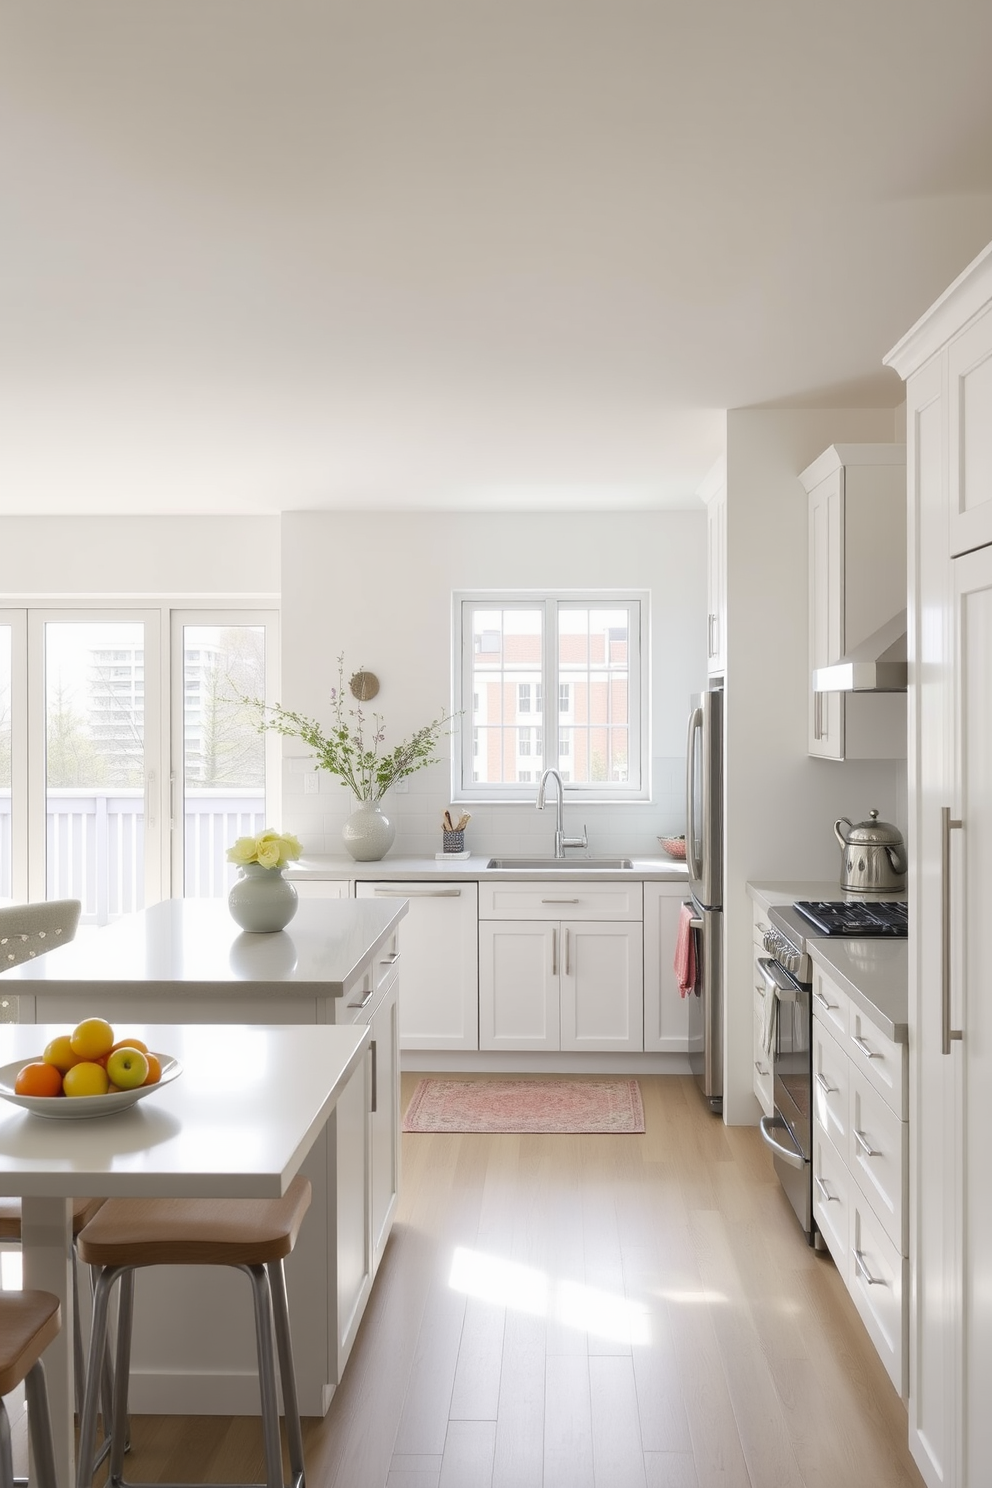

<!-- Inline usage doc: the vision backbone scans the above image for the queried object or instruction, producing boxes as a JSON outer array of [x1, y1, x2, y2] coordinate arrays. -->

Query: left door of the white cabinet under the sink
[[479, 920, 561, 1049]]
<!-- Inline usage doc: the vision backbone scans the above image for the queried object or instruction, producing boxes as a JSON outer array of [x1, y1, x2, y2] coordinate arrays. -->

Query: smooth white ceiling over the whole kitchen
[[0, 0, 992, 513]]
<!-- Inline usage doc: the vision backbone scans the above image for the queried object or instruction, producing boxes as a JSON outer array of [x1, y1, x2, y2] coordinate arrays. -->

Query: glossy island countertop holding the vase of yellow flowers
[[3, 899, 406, 997]]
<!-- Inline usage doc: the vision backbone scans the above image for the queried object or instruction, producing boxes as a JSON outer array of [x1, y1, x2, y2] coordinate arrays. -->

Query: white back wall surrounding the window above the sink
[[280, 506, 706, 863]]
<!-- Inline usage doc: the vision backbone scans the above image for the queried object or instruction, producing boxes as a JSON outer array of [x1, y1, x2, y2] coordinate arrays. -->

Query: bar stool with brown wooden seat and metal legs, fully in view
[[77, 1176, 311, 1488]]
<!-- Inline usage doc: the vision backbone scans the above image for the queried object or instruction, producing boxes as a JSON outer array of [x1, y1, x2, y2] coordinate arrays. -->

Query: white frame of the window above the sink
[[451, 589, 651, 804]]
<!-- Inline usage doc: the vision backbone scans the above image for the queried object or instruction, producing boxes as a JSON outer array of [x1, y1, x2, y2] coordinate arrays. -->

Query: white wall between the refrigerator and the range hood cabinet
[[724, 409, 906, 1123]]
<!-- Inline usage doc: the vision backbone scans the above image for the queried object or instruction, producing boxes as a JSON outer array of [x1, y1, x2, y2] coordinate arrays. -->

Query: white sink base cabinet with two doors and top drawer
[[479, 882, 644, 1052]]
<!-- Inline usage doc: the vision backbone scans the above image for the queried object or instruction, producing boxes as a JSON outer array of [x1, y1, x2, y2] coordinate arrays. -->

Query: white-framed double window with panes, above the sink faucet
[[452, 592, 647, 801]]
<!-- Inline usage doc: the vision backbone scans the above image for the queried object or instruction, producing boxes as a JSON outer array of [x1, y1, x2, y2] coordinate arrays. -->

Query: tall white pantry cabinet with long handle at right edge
[[886, 244, 992, 1488]]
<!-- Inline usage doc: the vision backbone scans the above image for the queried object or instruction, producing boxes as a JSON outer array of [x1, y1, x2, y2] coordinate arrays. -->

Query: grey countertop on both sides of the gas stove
[[748, 879, 909, 1043]]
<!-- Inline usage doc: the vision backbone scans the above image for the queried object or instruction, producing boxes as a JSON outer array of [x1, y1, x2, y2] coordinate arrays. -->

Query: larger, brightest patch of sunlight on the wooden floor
[[448, 1245, 651, 1344]]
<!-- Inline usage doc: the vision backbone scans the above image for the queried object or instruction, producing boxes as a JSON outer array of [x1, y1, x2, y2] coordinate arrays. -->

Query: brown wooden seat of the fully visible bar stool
[[77, 1177, 311, 1266]]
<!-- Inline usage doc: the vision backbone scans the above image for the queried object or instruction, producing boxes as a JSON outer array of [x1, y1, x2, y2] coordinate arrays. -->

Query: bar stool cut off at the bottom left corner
[[0, 1292, 62, 1488]]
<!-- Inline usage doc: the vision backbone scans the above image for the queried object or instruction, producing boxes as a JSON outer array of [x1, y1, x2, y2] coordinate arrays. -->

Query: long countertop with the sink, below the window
[[286, 851, 689, 882]]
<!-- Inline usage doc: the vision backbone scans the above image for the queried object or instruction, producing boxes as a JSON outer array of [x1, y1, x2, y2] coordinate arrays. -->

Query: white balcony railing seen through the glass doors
[[0, 789, 265, 924]]
